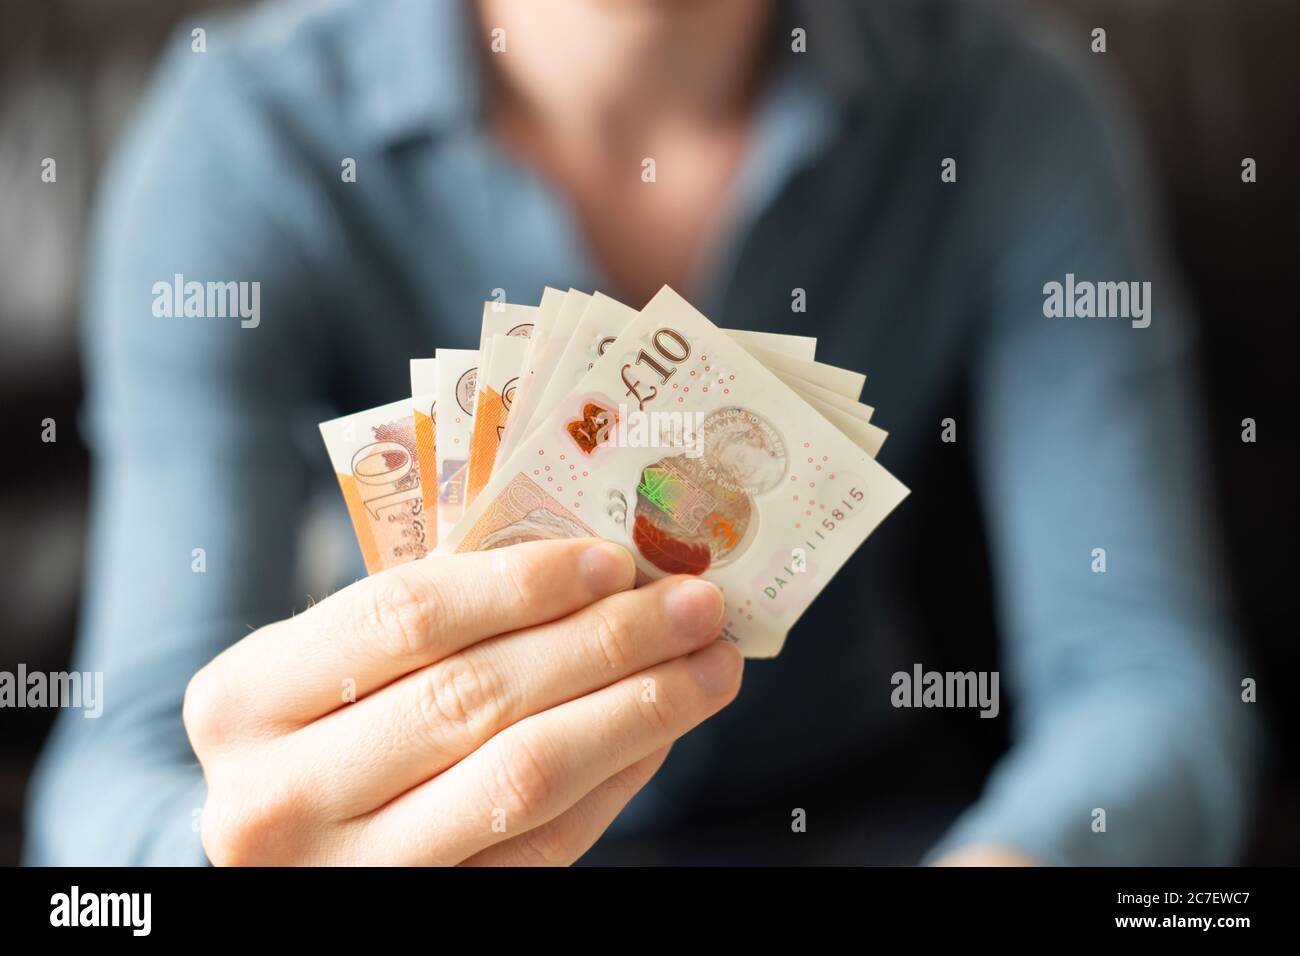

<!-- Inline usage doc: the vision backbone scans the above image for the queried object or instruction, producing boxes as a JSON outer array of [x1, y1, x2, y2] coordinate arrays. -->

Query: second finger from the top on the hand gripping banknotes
[[294, 576, 724, 819]]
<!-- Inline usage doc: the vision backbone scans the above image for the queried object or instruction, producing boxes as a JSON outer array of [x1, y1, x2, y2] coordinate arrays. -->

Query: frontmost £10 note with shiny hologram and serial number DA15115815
[[441, 287, 907, 657]]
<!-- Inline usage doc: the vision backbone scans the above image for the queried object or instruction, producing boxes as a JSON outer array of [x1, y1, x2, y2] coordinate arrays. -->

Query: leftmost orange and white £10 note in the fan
[[320, 401, 434, 574]]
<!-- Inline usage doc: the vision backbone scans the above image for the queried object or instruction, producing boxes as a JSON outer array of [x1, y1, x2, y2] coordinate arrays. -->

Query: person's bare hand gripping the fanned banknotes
[[183, 540, 741, 865]]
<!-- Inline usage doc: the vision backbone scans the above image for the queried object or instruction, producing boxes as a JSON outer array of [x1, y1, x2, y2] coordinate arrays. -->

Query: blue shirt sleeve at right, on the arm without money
[[931, 37, 1258, 865]]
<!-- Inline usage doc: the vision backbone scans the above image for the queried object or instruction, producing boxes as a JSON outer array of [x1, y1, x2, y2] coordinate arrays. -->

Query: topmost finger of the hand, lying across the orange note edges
[[186, 538, 636, 744]]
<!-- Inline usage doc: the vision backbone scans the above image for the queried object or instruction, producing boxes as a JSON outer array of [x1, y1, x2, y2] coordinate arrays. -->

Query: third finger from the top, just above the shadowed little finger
[[358, 641, 742, 864]]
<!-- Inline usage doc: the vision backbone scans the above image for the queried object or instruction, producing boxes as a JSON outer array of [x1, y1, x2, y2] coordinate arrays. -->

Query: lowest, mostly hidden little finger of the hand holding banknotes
[[462, 747, 671, 866]]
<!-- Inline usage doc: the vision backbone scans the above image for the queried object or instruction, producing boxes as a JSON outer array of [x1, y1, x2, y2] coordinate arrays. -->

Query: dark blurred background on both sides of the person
[[0, 0, 1300, 864]]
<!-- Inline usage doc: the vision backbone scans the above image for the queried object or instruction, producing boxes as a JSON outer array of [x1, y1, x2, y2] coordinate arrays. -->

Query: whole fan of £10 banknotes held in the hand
[[321, 286, 907, 657]]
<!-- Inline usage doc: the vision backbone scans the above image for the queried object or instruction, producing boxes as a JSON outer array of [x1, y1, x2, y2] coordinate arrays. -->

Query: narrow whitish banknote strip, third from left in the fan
[[433, 349, 478, 540]]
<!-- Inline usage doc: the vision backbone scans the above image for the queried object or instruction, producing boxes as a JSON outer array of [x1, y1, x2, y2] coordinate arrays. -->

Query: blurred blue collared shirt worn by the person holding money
[[27, 0, 1256, 864]]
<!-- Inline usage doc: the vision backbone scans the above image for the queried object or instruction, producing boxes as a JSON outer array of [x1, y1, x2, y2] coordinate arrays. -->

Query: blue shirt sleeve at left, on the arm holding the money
[[26, 34, 332, 865]]
